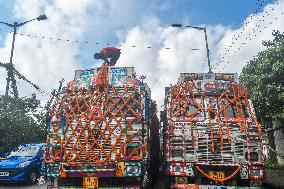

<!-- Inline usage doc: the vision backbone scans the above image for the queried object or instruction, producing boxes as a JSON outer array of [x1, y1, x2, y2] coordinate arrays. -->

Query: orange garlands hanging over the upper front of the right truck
[[167, 79, 261, 153]]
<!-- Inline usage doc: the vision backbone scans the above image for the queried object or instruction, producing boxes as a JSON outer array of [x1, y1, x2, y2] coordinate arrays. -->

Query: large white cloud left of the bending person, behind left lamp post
[[0, 0, 150, 99]]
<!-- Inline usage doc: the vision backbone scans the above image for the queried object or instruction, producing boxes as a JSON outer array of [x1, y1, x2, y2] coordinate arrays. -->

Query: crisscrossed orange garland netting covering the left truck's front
[[45, 64, 147, 165]]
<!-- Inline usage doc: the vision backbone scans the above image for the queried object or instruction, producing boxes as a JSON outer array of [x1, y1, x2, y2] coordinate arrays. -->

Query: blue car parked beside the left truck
[[0, 144, 45, 184]]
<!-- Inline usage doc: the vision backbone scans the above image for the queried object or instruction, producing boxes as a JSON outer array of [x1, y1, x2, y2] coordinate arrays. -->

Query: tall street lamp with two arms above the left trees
[[0, 14, 47, 98]]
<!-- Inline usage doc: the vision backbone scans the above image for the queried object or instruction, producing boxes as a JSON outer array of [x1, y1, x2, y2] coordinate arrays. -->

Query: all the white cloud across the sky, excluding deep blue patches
[[0, 0, 284, 111]]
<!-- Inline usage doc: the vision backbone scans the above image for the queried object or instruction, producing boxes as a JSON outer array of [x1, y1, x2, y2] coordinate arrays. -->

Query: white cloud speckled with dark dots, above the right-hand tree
[[216, 0, 284, 72]]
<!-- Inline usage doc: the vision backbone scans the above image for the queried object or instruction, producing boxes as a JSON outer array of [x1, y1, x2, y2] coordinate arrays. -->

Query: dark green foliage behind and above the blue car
[[0, 96, 45, 153]]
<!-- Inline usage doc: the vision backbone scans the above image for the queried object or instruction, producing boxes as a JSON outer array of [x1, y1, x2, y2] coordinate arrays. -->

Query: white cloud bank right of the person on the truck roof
[[118, 0, 284, 109]]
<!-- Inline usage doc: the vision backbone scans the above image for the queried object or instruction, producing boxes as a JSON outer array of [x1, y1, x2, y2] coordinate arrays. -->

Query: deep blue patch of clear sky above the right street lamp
[[153, 0, 272, 28]]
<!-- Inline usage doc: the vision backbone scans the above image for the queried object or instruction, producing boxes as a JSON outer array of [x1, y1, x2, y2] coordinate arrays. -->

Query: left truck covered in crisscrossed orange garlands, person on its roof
[[45, 64, 154, 189]]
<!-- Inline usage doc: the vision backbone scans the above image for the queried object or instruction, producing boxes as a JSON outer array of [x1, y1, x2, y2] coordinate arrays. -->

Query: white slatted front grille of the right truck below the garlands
[[169, 123, 251, 163]]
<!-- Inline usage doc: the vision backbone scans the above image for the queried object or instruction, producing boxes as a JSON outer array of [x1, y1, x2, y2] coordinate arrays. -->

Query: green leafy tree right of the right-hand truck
[[240, 31, 284, 121]]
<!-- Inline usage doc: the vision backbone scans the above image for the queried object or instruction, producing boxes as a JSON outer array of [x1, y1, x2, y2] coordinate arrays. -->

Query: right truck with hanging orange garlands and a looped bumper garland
[[161, 73, 264, 189]]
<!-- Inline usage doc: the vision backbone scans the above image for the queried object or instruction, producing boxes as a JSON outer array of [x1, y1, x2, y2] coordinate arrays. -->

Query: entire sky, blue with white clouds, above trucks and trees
[[0, 0, 284, 107]]
